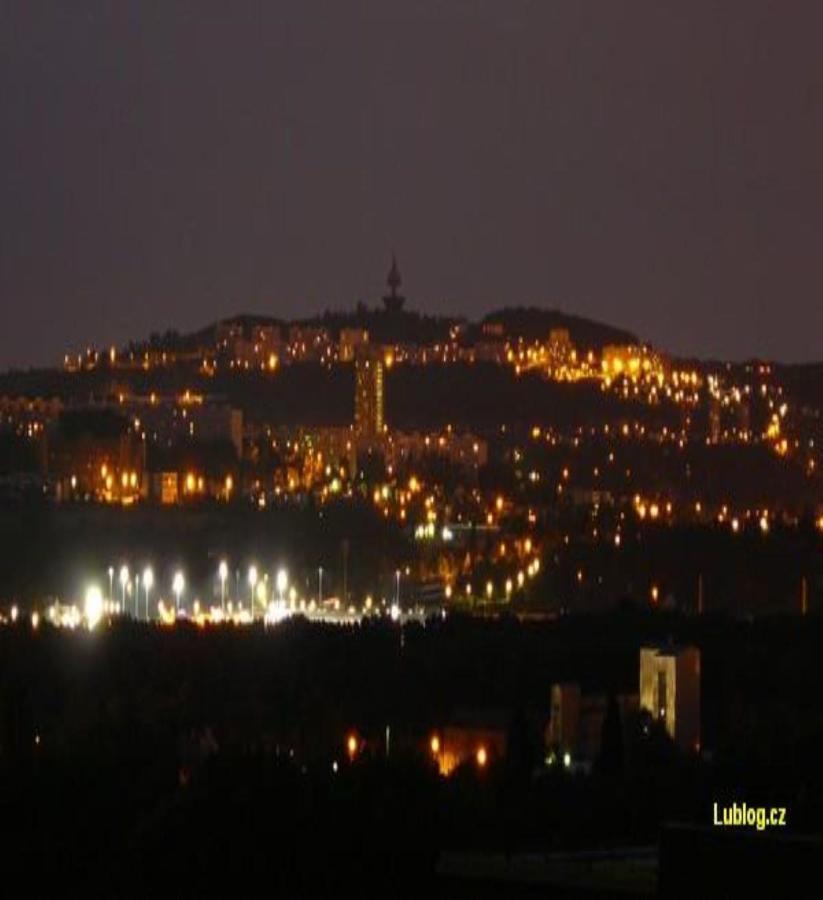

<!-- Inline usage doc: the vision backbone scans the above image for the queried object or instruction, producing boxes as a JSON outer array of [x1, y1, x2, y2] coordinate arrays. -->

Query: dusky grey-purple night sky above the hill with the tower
[[0, 0, 823, 366]]
